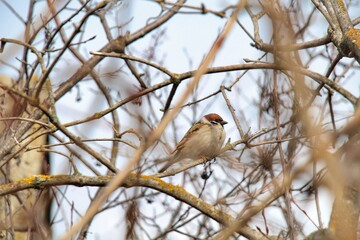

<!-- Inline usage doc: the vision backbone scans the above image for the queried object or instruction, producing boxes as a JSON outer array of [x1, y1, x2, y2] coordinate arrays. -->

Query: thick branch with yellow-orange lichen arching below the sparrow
[[0, 173, 266, 239]]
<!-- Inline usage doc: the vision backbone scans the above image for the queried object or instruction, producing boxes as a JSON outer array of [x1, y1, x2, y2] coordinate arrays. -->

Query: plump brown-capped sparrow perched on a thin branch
[[159, 113, 227, 172]]
